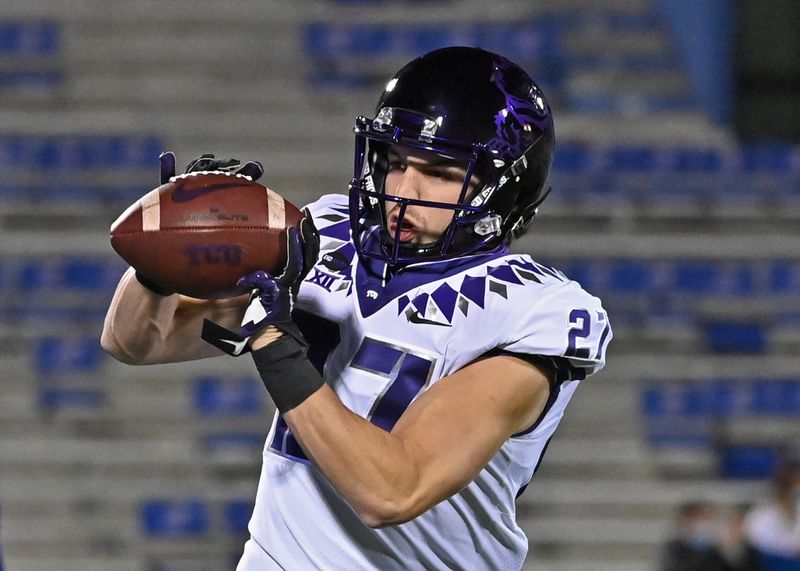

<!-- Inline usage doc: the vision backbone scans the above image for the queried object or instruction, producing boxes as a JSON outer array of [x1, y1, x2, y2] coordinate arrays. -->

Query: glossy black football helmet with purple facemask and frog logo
[[350, 47, 555, 265]]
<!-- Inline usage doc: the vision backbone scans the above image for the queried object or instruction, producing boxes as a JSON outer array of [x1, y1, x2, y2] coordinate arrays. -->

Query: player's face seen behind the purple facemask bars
[[386, 146, 478, 244]]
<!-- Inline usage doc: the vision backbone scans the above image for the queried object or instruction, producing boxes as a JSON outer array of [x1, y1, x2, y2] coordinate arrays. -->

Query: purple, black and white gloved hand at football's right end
[[236, 215, 319, 336]]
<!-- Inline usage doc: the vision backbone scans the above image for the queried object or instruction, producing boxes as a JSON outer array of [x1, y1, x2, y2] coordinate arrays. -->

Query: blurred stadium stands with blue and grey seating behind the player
[[0, 0, 800, 571]]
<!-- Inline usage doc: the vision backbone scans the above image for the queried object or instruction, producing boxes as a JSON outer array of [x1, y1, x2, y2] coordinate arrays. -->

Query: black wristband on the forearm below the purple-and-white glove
[[252, 335, 325, 414]]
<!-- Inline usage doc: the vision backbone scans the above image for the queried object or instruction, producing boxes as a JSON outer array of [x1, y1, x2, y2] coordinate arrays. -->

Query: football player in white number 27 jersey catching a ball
[[102, 47, 612, 571]]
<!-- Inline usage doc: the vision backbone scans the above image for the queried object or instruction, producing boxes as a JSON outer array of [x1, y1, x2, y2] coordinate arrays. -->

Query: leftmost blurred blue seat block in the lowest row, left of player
[[140, 498, 210, 539]]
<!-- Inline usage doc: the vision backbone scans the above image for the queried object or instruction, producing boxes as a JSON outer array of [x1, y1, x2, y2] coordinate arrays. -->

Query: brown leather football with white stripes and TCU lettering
[[111, 171, 303, 299]]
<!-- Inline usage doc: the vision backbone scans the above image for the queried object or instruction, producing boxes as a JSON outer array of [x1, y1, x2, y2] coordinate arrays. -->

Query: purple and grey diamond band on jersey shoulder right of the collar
[[397, 259, 567, 327]]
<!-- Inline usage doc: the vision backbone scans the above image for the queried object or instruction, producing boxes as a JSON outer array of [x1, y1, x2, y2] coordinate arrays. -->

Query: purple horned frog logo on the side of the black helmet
[[486, 61, 547, 161]]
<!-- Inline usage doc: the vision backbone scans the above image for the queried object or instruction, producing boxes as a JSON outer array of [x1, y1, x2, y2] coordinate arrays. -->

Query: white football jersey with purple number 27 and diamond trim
[[238, 195, 611, 571]]
